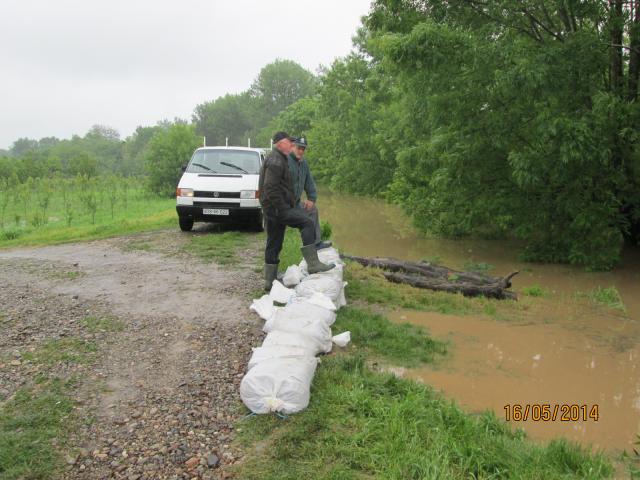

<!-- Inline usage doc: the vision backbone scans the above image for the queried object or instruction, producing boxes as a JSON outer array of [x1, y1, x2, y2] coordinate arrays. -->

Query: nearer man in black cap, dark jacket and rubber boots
[[259, 132, 335, 290]]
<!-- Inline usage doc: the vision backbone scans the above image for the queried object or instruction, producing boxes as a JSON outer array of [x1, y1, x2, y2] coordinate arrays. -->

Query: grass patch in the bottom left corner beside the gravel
[[0, 379, 73, 480]]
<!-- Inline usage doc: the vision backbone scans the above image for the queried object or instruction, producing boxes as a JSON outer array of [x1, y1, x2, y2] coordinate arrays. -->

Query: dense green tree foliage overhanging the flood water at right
[[273, 0, 640, 269]]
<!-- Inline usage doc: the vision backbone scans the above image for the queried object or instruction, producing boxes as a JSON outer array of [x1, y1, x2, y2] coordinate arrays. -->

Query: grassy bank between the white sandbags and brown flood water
[[233, 232, 613, 479]]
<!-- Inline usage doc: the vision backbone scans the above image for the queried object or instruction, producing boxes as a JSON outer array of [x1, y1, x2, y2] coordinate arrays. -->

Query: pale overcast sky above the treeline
[[0, 0, 371, 148]]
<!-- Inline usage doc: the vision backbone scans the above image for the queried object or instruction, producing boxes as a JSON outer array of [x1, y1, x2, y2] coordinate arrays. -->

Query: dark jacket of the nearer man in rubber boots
[[258, 148, 295, 211]]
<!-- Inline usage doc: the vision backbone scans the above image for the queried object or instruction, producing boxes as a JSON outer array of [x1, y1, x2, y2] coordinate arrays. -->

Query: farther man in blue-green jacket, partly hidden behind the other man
[[289, 136, 331, 250]]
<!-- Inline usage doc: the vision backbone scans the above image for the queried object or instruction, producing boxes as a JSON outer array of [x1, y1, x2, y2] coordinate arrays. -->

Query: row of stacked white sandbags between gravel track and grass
[[240, 248, 349, 414]]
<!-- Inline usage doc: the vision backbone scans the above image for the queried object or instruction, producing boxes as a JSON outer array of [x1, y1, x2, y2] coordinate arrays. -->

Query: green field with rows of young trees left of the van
[[0, 176, 176, 247]]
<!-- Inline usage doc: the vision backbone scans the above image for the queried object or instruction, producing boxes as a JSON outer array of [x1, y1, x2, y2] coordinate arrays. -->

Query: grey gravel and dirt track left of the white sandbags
[[0, 231, 261, 480]]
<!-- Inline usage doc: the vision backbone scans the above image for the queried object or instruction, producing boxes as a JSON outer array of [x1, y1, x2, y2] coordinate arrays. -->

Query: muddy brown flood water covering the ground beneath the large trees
[[318, 192, 640, 453]]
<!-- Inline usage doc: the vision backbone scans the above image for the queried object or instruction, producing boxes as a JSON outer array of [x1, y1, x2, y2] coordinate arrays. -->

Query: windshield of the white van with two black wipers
[[186, 149, 260, 174]]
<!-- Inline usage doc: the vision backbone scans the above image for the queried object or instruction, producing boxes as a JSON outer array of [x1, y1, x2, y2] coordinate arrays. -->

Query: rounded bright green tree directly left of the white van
[[145, 124, 201, 197]]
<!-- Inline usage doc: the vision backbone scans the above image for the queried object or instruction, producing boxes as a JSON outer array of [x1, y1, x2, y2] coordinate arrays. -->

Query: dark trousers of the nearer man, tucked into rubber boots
[[263, 207, 316, 265]]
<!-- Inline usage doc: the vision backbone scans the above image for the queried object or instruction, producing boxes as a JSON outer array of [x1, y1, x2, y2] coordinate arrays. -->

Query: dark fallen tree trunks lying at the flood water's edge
[[341, 255, 518, 299]]
